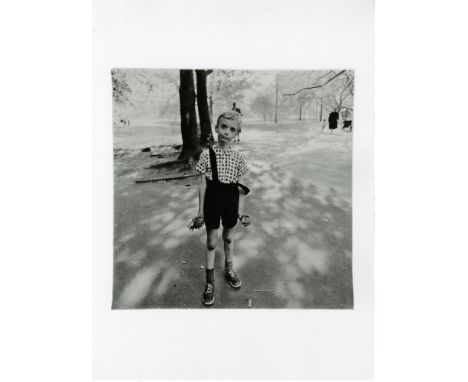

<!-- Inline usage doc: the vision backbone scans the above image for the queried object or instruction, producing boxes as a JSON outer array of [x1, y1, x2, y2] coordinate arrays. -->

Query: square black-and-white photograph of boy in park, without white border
[[114, 68, 359, 309]]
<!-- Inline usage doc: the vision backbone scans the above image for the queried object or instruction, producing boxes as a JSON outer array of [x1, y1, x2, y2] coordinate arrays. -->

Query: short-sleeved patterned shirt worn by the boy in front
[[195, 145, 247, 183]]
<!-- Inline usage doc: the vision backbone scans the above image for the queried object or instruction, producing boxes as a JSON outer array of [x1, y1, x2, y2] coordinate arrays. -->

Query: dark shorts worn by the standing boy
[[203, 179, 239, 229]]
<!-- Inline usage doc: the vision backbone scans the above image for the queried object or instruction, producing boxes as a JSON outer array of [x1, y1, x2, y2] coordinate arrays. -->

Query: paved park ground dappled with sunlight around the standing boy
[[113, 121, 353, 309]]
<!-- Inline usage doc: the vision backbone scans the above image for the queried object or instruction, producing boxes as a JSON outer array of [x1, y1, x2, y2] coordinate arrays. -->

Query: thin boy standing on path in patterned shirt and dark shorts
[[196, 111, 250, 306]]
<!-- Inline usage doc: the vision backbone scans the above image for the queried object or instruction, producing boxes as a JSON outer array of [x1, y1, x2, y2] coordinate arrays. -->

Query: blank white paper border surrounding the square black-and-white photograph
[[93, 0, 373, 379]]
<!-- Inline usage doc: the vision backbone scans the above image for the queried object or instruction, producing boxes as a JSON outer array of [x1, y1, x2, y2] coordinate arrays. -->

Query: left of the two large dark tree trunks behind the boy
[[179, 70, 201, 164]]
